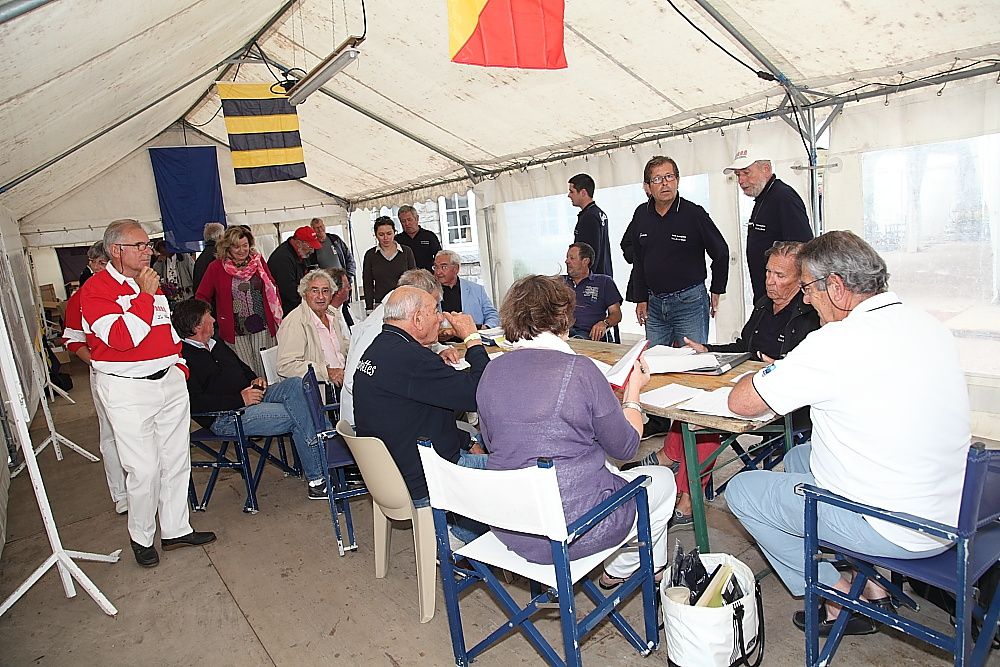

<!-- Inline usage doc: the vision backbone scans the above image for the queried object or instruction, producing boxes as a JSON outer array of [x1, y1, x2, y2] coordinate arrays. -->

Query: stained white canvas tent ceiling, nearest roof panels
[[0, 0, 1000, 217]]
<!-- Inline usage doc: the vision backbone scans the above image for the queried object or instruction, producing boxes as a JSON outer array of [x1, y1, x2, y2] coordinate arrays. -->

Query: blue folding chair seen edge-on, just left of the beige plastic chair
[[302, 364, 368, 556]]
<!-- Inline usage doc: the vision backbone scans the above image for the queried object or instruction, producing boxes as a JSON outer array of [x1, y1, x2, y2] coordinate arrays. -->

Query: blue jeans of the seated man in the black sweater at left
[[212, 378, 323, 481]]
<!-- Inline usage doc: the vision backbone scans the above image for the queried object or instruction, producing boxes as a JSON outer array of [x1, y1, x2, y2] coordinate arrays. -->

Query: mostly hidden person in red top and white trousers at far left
[[63, 241, 128, 514]]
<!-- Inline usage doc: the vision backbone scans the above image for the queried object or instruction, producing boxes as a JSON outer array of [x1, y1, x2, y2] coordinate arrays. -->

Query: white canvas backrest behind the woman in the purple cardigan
[[417, 440, 567, 542]]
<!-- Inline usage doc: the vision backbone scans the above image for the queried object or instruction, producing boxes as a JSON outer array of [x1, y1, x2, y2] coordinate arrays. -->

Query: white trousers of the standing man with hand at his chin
[[97, 366, 191, 547]]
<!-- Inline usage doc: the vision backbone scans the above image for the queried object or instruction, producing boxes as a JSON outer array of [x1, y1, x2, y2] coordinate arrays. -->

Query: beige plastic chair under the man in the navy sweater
[[337, 419, 437, 623]]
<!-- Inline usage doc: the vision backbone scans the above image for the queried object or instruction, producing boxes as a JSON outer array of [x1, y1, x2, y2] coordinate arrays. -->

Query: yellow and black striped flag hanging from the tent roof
[[215, 81, 306, 185]]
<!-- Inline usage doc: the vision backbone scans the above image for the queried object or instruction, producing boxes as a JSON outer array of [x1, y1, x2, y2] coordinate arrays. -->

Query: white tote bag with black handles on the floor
[[660, 554, 764, 667]]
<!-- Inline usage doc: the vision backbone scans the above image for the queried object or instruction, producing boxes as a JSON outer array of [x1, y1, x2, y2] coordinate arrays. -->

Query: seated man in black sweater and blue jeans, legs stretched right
[[170, 299, 326, 500]]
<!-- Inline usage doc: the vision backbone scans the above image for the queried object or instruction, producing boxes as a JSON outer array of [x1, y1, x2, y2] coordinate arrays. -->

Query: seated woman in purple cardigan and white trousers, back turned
[[476, 276, 677, 589]]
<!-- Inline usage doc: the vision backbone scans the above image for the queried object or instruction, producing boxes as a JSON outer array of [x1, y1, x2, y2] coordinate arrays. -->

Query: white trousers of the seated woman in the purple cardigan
[[604, 466, 677, 579]]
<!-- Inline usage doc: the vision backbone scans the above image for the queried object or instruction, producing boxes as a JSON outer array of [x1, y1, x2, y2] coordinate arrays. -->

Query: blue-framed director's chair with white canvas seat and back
[[417, 440, 659, 666]]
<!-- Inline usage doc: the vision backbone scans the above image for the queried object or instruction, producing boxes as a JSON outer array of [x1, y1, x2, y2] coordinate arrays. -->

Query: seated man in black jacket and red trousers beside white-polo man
[[642, 241, 819, 527]]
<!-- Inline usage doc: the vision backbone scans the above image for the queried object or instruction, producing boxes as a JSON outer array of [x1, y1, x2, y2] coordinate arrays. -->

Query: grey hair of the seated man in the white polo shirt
[[799, 231, 889, 294]]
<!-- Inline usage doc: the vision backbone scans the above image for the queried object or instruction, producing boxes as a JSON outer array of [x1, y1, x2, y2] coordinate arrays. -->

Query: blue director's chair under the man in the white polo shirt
[[801, 443, 1000, 667]]
